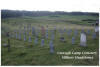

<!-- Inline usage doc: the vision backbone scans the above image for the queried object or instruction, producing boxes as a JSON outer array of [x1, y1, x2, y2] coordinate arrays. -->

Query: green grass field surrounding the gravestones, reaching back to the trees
[[1, 15, 99, 66]]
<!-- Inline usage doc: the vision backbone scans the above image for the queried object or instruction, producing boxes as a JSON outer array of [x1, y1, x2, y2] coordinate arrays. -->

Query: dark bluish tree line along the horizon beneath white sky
[[1, 10, 99, 18]]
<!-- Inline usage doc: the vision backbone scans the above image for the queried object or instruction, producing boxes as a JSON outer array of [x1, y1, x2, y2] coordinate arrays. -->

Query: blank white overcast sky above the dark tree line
[[0, 0, 100, 12]]
